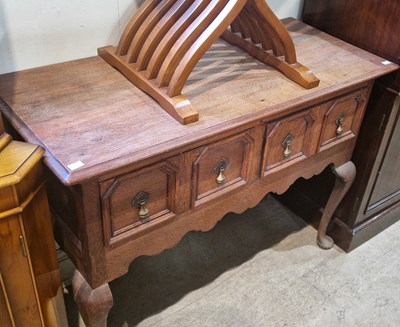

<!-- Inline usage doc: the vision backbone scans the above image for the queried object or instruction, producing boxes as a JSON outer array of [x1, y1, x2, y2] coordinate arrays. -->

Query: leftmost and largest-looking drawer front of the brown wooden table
[[100, 161, 178, 245]]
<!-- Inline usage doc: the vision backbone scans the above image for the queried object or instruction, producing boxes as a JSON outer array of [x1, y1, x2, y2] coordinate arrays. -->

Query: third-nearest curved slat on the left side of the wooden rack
[[146, 0, 211, 79]]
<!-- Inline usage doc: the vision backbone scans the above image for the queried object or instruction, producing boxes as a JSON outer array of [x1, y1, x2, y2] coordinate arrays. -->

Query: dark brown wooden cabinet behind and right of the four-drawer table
[[276, 0, 400, 251]]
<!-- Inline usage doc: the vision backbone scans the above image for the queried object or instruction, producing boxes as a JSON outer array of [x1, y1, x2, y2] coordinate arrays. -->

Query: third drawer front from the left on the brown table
[[262, 107, 319, 175]]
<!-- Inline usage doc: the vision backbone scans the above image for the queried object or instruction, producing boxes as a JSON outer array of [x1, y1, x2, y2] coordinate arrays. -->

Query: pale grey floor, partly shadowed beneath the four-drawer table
[[65, 197, 400, 327]]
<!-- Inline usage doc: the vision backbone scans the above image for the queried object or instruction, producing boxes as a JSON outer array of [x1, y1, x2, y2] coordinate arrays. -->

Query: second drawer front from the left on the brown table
[[191, 130, 254, 206]]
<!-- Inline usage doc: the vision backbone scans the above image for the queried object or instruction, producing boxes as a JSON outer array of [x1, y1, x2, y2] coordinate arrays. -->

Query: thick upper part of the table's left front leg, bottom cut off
[[72, 270, 113, 327]]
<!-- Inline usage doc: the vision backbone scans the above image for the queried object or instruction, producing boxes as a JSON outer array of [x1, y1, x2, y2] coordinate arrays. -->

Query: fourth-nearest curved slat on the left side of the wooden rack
[[136, 0, 193, 70]]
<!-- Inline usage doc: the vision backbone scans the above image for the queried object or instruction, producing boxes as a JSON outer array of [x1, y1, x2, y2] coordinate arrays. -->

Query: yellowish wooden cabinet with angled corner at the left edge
[[0, 134, 67, 327]]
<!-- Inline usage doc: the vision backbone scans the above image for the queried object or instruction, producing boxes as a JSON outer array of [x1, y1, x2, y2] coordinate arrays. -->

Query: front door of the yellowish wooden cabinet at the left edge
[[0, 215, 42, 327]]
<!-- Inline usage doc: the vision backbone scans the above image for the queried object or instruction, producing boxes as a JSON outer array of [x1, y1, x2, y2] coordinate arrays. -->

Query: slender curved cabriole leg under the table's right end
[[317, 161, 356, 250]]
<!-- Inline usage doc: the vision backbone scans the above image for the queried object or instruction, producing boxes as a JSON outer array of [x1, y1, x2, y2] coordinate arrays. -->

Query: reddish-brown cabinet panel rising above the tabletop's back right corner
[[302, 0, 400, 63]]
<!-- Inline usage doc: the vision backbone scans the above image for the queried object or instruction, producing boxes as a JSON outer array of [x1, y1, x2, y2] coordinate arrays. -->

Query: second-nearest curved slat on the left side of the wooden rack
[[156, 0, 228, 87]]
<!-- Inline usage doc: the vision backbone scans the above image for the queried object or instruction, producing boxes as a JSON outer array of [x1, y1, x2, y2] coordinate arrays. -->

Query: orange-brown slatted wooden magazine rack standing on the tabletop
[[98, 0, 319, 124]]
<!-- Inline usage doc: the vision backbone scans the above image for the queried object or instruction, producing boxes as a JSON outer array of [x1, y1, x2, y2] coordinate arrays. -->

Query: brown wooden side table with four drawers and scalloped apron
[[0, 19, 397, 326]]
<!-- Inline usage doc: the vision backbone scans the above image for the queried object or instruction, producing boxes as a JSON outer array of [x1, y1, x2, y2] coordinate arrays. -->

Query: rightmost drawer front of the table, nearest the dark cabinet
[[319, 88, 367, 151]]
